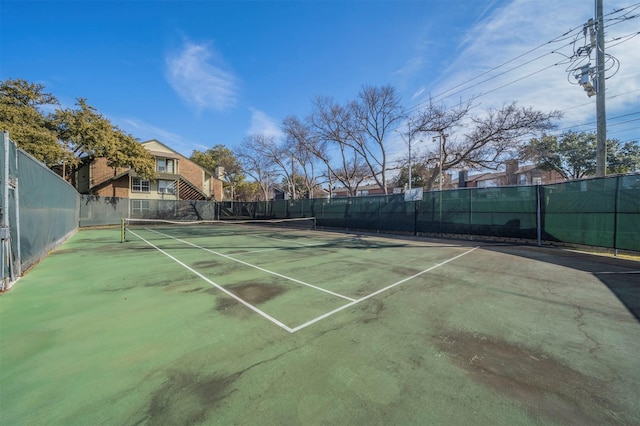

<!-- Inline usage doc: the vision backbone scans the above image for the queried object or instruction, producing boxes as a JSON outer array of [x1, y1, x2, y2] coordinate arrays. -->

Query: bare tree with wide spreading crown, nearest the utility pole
[[410, 101, 562, 190]]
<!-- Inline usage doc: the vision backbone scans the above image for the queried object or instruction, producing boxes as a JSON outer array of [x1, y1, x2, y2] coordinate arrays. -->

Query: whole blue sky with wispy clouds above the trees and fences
[[0, 0, 640, 161]]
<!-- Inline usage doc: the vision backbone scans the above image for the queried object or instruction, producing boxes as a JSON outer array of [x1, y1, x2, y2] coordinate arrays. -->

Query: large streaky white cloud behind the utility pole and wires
[[423, 0, 640, 139]]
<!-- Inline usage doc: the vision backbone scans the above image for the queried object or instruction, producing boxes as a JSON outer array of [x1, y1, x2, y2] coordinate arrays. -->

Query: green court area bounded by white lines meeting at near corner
[[128, 220, 474, 333]]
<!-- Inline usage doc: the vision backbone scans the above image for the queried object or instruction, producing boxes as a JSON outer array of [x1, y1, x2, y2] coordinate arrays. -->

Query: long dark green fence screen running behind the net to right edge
[[81, 174, 640, 251]]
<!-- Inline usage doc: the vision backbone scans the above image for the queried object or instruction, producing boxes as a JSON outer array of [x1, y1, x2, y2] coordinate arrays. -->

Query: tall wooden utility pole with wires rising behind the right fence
[[596, 0, 607, 177]]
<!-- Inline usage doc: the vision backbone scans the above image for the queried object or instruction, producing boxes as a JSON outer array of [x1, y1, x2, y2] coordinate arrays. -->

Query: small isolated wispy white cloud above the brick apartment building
[[166, 41, 238, 111]]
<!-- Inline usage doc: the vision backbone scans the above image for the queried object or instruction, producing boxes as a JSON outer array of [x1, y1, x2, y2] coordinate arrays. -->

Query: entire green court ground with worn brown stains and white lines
[[0, 226, 640, 425]]
